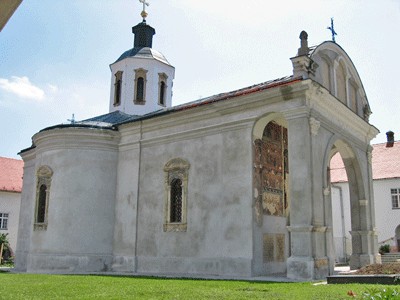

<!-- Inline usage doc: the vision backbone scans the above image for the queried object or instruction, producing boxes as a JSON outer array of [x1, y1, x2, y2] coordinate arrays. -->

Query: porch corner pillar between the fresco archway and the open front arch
[[285, 112, 314, 280]]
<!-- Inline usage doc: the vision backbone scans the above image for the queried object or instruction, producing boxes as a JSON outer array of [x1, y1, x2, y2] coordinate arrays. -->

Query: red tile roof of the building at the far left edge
[[0, 157, 24, 193]]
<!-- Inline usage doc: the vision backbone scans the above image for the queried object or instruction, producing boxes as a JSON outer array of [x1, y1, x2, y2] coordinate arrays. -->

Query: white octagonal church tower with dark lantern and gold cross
[[109, 0, 175, 115]]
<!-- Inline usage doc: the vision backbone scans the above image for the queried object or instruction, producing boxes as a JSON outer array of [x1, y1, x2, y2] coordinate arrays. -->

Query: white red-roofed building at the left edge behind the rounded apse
[[0, 157, 24, 252]]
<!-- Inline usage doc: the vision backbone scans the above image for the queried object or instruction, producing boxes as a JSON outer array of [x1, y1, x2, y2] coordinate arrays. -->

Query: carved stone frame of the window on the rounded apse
[[33, 166, 53, 230]]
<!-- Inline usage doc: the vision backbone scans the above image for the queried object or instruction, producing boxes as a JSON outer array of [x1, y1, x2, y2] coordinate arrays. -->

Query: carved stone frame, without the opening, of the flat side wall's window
[[163, 158, 190, 232]]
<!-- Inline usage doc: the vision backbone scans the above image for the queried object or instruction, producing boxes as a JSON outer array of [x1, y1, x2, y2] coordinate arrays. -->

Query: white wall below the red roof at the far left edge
[[0, 191, 21, 252]]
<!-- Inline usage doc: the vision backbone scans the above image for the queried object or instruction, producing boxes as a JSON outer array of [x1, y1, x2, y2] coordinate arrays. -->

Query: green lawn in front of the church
[[0, 272, 398, 300]]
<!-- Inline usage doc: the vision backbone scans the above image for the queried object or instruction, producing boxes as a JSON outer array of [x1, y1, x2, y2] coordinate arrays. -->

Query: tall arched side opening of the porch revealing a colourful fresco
[[253, 113, 290, 275]]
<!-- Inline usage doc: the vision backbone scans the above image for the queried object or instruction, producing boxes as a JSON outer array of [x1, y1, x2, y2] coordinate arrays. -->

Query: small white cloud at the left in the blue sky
[[0, 76, 45, 101]]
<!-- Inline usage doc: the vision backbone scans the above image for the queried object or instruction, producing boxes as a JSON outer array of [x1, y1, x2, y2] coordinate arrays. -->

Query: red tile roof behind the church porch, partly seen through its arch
[[330, 141, 400, 182]]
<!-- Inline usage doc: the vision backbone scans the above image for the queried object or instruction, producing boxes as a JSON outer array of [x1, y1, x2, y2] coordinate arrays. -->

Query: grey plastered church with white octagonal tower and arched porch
[[16, 6, 380, 280]]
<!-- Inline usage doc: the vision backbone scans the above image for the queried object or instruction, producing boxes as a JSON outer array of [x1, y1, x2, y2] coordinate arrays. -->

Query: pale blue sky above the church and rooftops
[[0, 0, 400, 158]]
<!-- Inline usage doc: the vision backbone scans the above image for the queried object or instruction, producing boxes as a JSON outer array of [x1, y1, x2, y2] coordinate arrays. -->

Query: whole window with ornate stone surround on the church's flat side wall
[[163, 158, 190, 232]]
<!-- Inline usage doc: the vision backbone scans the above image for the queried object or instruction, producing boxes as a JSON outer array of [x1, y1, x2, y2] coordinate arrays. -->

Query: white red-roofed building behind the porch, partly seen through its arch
[[330, 131, 400, 262]]
